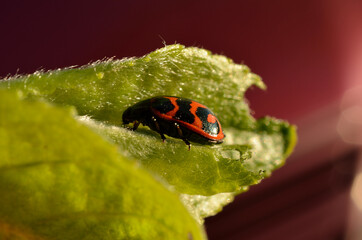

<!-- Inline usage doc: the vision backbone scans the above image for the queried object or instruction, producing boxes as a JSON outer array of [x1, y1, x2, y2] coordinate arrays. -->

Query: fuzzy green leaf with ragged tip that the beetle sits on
[[0, 45, 296, 219]]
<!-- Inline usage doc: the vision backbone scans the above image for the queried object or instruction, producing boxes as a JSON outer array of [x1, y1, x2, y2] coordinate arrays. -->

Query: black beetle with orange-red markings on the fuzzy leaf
[[122, 96, 225, 150]]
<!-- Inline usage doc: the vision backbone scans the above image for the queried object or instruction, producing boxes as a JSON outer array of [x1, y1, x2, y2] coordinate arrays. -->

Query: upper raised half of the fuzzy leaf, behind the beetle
[[0, 45, 265, 128]]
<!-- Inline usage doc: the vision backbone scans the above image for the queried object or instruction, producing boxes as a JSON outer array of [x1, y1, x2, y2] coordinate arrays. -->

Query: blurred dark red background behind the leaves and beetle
[[0, 0, 362, 240]]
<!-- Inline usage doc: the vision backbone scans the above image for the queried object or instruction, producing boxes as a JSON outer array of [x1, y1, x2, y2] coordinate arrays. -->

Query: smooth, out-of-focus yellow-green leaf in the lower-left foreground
[[0, 89, 205, 240]]
